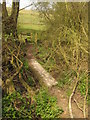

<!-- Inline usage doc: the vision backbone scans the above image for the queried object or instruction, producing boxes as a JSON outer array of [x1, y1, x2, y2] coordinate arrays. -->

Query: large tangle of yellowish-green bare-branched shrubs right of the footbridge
[[35, 2, 88, 79]]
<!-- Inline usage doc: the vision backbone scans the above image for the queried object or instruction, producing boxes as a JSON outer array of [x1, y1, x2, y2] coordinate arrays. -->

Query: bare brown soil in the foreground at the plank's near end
[[49, 86, 83, 118]]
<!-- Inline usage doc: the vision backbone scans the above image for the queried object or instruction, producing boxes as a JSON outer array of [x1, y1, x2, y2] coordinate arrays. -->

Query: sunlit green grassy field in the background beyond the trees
[[18, 10, 45, 33]]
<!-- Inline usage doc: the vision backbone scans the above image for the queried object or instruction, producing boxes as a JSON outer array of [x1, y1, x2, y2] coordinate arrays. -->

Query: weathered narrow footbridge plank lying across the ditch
[[29, 58, 57, 87]]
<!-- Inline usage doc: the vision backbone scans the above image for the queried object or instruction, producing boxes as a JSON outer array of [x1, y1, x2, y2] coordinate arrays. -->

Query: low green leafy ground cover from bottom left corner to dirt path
[[2, 90, 63, 119]]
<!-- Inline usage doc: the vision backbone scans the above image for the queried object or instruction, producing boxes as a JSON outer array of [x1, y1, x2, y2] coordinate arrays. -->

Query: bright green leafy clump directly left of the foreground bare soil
[[35, 90, 63, 118]]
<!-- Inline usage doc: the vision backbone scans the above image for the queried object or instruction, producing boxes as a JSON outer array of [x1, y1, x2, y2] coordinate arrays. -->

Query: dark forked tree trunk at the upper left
[[2, 2, 19, 37]]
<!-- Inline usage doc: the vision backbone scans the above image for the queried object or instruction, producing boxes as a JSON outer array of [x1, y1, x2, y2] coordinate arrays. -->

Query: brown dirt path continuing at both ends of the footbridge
[[27, 45, 83, 118]]
